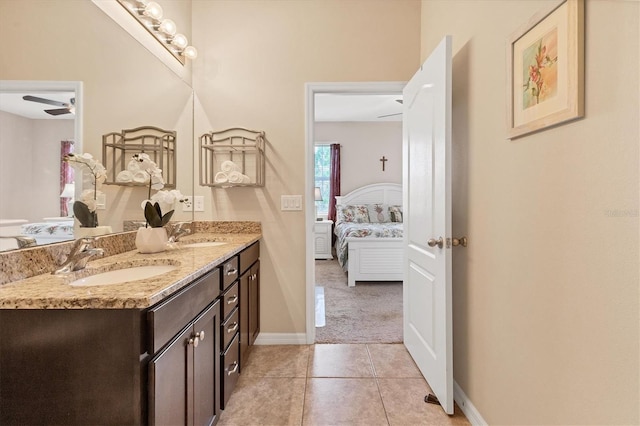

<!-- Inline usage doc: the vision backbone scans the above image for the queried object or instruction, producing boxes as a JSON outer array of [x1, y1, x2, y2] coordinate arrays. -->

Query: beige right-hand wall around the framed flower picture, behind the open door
[[421, 0, 640, 424]]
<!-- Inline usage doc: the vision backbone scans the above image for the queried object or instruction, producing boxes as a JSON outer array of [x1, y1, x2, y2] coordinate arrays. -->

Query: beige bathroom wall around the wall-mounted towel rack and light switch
[[192, 0, 420, 333]]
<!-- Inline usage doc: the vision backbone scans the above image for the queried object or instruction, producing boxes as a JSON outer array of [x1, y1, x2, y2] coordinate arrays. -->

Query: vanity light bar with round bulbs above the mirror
[[117, 0, 198, 65]]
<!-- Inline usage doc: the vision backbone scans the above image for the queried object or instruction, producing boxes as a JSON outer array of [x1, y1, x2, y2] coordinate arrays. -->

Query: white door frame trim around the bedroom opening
[[304, 81, 406, 345]]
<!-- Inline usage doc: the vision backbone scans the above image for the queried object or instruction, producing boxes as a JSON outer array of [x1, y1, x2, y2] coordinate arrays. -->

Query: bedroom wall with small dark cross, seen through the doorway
[[314, 121, 402, 195]]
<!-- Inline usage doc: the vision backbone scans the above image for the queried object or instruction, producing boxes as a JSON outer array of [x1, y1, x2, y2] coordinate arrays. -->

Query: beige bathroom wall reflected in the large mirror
[[0, 0, 193, 231]]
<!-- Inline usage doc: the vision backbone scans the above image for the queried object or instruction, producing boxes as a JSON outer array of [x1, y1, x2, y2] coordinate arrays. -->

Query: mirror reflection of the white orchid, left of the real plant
[[63, 152, 107, 228]]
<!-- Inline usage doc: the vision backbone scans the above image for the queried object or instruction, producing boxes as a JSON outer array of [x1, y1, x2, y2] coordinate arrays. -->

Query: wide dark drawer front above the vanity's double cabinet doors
[[147, 269, 220, 354]]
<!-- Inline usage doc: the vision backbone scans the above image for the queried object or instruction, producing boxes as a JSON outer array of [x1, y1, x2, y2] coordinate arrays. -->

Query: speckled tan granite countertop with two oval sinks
[[0, 233, 261, 309]]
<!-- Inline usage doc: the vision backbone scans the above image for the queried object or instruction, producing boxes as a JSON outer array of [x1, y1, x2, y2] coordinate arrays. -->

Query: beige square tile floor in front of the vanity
[[218, 344, 469, 426]]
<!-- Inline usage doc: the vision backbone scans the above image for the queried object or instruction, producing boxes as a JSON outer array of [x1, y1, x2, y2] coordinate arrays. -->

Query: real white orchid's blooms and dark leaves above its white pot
[[131, 153, 186, 228]]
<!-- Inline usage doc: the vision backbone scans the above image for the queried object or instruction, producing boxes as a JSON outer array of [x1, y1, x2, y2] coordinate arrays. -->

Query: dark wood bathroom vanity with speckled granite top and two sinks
[[0, 230, 260, 425]]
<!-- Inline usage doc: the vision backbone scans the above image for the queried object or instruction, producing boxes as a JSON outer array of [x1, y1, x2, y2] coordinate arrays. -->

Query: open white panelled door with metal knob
[[402, 36, 453, 414]]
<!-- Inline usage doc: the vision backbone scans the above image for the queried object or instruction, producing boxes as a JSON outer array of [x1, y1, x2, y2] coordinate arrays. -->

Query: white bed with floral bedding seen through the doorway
[[334, 183, 404, 287]]
